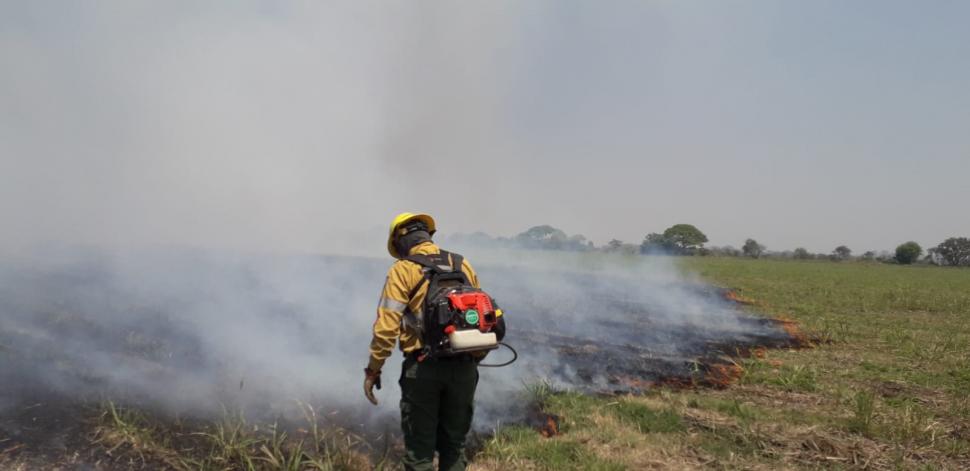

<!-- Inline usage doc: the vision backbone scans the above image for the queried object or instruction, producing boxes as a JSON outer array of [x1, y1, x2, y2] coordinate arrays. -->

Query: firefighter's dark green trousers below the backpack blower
[[399, 358, 478, 471]]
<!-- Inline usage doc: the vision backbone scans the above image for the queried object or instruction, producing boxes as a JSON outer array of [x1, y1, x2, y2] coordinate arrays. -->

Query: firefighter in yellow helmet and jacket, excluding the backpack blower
[[364, 213, 492, 471]]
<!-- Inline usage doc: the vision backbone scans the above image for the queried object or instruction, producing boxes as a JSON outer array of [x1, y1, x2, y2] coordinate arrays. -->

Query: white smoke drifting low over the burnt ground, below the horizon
[[0, 243, 780, 428]]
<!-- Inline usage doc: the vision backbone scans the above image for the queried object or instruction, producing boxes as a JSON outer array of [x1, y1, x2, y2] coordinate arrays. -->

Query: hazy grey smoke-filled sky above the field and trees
[[0, 1, 970, 253]]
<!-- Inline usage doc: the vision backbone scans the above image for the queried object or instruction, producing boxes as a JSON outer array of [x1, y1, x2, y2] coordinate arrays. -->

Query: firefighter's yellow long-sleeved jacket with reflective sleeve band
[[367, 242, 479, 371]]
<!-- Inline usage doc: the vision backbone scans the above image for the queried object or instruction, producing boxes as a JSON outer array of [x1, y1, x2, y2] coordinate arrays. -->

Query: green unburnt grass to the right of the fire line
[[475, 258, 970, 470]]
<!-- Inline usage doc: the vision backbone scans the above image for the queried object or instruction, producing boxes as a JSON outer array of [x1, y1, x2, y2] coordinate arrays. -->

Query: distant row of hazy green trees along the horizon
[[447, 224, 970, 267]]
